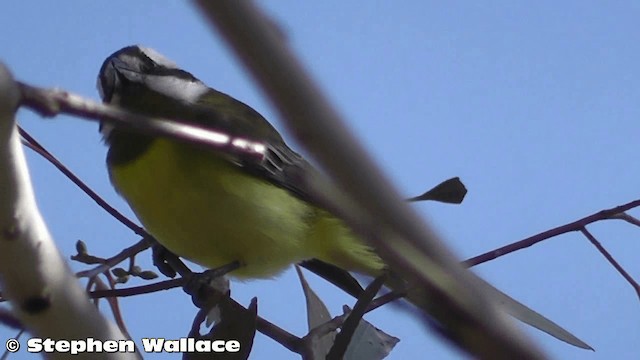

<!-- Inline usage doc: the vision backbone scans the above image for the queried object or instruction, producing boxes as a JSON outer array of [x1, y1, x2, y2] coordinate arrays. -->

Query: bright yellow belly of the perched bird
[[110, 140, 317, 277]]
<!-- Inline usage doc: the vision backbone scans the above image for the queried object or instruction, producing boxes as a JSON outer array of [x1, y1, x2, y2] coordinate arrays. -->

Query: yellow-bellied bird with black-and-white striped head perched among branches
[[97, 45, 588, 348]]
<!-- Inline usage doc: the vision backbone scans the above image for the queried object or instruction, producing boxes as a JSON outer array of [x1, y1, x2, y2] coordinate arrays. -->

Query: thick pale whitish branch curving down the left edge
[[0, 65, 137, 359]]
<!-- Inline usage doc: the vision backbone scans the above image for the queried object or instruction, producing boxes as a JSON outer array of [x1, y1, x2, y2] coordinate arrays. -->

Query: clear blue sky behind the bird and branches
[[0, 0, 640, 359]]
